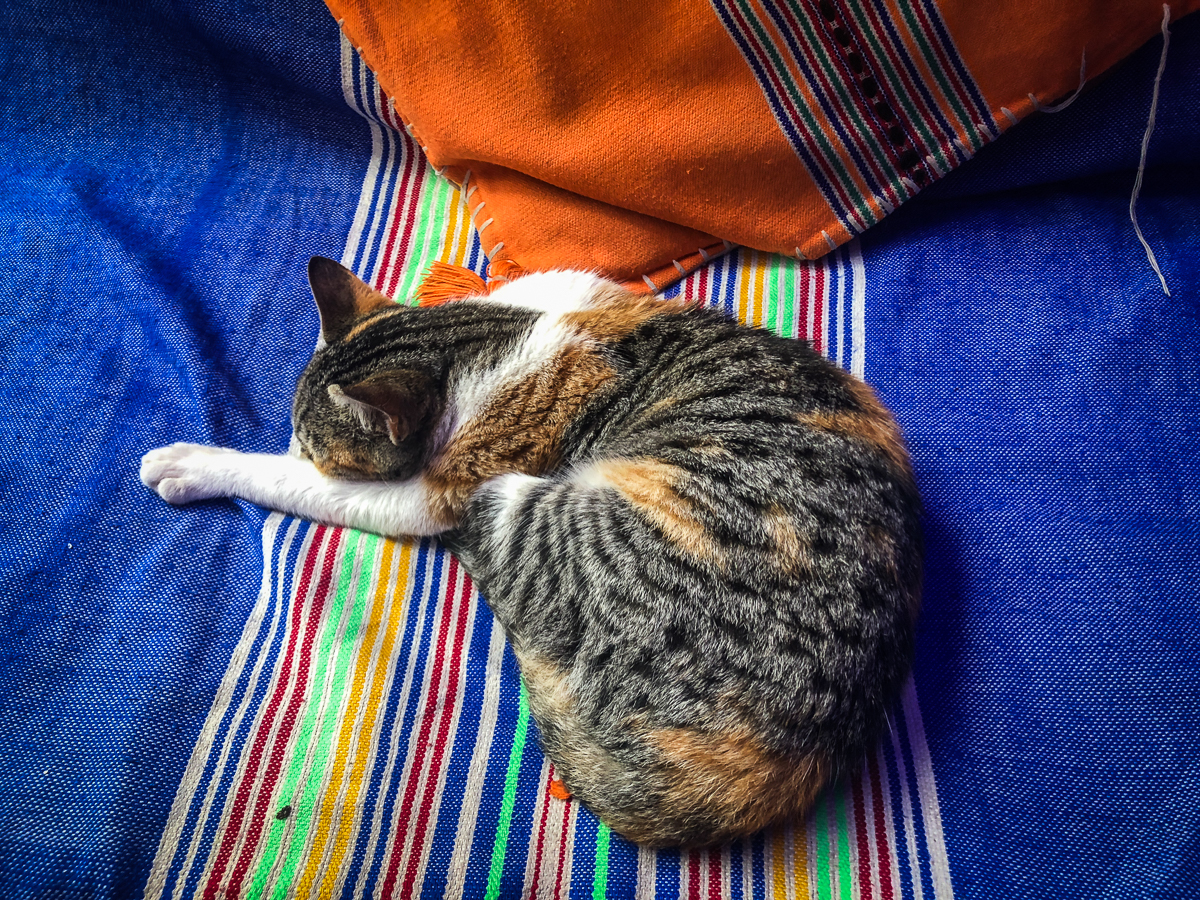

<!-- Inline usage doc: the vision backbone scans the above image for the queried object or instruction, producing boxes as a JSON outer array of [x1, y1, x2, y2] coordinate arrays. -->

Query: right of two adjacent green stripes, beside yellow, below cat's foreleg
[[267, 532, 379, 900]]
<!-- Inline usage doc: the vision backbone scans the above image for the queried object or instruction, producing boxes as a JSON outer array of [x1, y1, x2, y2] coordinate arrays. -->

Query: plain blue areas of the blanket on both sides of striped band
[[0, 0, 1200, 898]]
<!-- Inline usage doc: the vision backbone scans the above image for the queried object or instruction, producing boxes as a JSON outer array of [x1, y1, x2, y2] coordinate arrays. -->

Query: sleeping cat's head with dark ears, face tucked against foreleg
[[292, 257, 444, 480]]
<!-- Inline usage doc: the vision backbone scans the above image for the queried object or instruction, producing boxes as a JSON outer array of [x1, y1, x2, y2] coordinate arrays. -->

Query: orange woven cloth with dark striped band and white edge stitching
[[328, 0, 1200, 289]]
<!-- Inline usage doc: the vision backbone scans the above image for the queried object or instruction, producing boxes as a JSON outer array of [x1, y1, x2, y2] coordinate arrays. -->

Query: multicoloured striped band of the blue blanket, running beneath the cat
[[145, 41, 952, 900]]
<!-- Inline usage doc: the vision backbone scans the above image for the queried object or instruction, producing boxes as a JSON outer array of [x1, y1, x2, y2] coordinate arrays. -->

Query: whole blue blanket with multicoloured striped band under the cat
[[0, 0, 1200, 900]]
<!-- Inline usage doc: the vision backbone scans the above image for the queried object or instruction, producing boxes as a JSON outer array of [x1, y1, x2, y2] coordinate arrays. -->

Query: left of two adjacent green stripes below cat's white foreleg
[[246, 530, 361, 898]]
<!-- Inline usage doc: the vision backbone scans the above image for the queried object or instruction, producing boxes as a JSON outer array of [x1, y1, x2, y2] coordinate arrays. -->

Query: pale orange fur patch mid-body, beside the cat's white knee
[[593, 460, 725, 565]]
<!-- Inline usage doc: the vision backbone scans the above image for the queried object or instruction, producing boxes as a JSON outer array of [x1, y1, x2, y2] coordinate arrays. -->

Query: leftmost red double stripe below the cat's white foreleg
[[203, 526, 342, 900]]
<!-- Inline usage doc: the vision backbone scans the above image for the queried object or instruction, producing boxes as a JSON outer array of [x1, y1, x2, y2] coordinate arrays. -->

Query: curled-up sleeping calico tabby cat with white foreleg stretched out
[[142, 257, 922, 846]]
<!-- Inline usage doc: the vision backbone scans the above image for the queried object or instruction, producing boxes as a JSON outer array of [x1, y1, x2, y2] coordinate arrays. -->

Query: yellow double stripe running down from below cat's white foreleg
[[307, 540, 413, 900]]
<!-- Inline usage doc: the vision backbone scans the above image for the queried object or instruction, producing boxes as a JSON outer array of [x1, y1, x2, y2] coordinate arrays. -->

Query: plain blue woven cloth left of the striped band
[[0, 0, 370, 900]]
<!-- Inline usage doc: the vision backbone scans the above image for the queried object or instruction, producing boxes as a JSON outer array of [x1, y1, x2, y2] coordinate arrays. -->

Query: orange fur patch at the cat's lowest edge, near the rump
[[643, 728, 827, 841]]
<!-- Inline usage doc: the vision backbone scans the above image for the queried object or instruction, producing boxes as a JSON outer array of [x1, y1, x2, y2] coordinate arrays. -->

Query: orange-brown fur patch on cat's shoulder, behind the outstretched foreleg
[[430, 347, 616, 512]]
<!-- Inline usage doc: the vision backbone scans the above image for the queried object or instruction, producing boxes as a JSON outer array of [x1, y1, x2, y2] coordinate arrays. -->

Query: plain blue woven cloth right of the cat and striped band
[[863, 17, 1200, 898]]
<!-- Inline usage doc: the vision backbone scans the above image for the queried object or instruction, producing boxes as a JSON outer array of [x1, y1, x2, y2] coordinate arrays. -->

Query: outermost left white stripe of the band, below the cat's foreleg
[[145, 512, 287, 900]]
